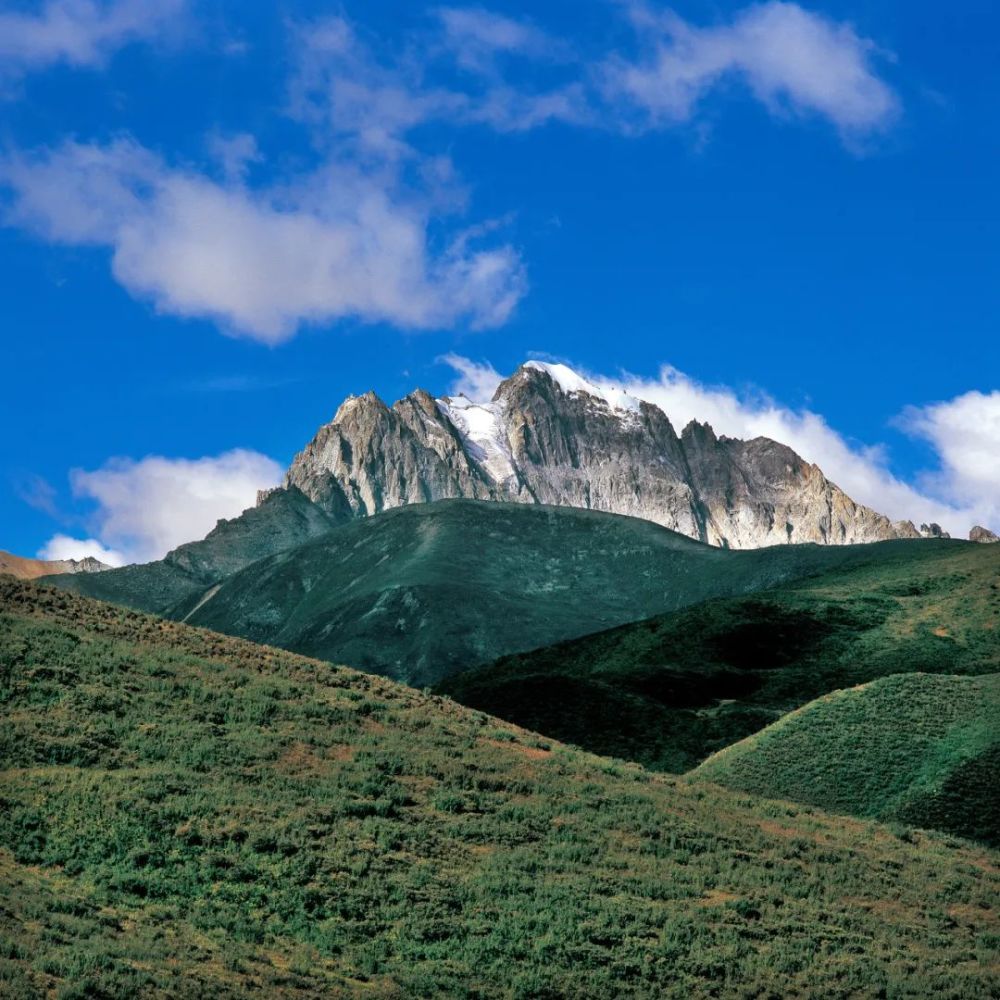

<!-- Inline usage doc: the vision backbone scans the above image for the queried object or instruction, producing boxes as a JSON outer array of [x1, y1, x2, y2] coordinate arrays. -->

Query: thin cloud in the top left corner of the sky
[[0, 0, 186, 76]]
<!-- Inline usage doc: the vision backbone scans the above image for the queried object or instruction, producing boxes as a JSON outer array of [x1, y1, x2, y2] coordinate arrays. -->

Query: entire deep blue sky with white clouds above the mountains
[[0, 0, 1000, 563]]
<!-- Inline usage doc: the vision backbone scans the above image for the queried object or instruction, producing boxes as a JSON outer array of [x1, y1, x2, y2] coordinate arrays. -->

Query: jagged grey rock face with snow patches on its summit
[[285, 362, 920, 549]]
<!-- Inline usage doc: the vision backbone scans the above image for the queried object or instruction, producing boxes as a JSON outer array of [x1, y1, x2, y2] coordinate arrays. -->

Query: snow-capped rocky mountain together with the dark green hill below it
[[45, 362, 992, 684]]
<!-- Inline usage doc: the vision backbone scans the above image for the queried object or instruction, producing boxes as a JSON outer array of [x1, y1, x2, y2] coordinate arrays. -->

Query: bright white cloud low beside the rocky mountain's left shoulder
[[42, 449, 282, 564]]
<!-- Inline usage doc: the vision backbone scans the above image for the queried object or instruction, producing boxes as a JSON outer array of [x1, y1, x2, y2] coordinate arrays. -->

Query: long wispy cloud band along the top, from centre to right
[[292, 0, 900, 153]]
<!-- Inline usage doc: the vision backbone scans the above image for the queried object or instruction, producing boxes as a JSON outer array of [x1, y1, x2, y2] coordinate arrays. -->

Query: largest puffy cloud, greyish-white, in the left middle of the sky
[[0, 139, 526, 343]]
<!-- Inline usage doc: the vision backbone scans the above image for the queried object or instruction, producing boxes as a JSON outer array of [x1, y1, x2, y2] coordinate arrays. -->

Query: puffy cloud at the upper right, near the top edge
[[605, 0, 899, 137]]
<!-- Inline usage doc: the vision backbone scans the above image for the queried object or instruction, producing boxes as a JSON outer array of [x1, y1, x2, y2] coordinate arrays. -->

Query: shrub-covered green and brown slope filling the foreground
[[0, 579, 1000, 1000]]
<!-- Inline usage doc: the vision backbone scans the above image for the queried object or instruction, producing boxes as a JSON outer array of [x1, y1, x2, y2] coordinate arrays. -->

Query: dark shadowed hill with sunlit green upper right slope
[[442, 540, 1000, 771]]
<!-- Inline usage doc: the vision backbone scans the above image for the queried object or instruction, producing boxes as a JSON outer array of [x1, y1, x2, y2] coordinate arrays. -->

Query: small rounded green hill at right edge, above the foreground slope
[[694, 674, 1000, 847]]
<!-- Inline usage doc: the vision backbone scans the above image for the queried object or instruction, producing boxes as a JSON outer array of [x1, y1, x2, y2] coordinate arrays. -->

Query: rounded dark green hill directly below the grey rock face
[[94, 500, 930, 685]]
